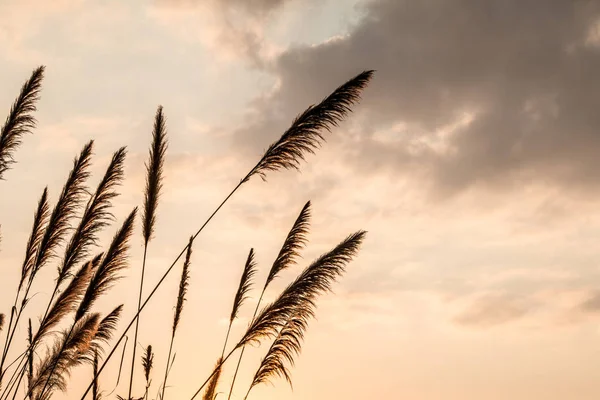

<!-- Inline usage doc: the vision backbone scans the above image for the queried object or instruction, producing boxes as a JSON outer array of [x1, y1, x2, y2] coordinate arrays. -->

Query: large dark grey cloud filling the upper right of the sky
[[236, 0, 600, 195]]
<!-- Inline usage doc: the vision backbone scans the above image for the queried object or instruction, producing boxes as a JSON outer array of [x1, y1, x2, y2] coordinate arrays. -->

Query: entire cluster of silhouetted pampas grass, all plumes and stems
[[0, 67, 373, 400]]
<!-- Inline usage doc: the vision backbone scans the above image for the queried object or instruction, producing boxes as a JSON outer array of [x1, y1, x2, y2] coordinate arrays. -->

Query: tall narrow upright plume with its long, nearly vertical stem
[[127, 106, 167, 398]]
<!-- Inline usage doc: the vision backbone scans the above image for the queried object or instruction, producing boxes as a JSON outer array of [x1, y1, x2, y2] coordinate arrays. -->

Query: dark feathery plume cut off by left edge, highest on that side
[[0, 66, 44, 180]]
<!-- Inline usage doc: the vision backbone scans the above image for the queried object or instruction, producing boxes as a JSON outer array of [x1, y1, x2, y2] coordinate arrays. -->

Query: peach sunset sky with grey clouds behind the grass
[[0, 0, 600, 400]]
